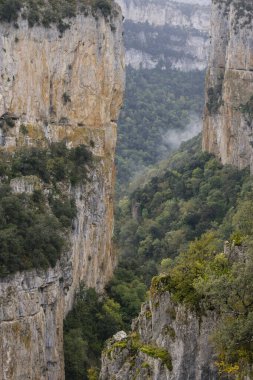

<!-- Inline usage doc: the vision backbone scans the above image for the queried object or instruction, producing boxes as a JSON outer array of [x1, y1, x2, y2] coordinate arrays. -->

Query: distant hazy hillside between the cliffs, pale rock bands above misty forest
[[117, 0, 210, 189]]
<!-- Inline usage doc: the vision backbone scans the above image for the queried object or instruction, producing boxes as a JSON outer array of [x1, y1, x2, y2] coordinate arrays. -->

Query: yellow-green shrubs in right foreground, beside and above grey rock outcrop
[[151, 174, 253, 378]]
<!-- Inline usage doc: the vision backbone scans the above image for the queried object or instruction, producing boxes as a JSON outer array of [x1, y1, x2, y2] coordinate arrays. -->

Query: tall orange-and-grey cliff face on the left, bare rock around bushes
[[0, 5, 124, 380]]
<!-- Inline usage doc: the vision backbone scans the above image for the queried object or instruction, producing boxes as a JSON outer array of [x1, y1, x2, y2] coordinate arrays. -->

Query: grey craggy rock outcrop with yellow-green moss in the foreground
[[100, 292, 218, 380]]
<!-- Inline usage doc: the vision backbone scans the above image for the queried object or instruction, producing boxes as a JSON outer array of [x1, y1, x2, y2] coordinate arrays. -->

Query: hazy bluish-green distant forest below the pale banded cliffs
[[116, 67, 205, 191]]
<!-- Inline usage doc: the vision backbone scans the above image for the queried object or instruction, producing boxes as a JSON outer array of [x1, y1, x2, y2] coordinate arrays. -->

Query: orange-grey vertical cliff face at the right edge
[[203, 0, 253, 171]]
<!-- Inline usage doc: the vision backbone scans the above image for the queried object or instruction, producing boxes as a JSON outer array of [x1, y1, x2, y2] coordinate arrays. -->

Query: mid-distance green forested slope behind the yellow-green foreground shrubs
[[108, 137, 247, 322]]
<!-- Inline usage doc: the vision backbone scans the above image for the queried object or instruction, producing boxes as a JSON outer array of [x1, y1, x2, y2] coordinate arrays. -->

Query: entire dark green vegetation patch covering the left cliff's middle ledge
[[0, 143, 92, 276]]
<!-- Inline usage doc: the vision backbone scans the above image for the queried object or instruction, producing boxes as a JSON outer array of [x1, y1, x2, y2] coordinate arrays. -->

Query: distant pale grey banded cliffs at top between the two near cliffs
[[118, 0, 210, 71]]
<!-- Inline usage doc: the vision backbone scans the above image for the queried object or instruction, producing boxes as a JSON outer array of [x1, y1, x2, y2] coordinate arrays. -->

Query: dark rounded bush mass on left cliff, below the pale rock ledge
[[0, 186, 64, 276]]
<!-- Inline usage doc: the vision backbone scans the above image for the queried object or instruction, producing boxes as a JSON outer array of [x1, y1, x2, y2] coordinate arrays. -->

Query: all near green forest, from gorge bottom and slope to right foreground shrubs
[[65, 136, 253, 379]]
